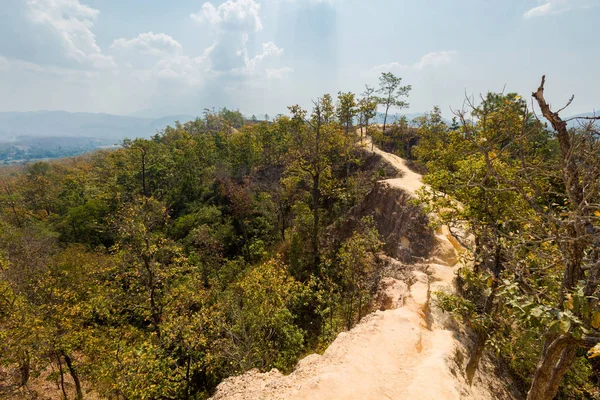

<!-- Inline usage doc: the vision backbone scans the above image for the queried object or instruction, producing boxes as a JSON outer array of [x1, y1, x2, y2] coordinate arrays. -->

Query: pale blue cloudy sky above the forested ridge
[[0, 0, 600, 117]]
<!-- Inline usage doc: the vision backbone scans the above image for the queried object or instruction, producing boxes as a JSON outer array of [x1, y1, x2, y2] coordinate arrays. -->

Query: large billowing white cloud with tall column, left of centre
[[106, 0, 291, 90]]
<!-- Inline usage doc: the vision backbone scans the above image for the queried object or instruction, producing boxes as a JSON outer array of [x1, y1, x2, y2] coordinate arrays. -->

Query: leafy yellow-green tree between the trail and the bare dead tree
[[415, 93, 541, 380]]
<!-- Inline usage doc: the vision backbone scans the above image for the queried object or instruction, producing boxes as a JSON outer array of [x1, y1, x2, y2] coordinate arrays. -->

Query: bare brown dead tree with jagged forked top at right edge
[[527, 76, 600, 400]]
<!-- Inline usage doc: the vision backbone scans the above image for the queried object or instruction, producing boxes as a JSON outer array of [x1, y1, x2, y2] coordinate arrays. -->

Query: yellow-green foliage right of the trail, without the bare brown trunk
[[414, 93, 600, 398]]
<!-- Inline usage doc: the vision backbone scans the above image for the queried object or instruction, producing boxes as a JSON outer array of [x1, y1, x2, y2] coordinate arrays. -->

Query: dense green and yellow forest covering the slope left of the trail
[[0, 93, 390, 399]]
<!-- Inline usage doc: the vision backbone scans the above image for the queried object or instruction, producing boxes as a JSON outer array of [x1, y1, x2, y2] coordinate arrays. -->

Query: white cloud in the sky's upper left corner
[[26, 0, 115, 68]]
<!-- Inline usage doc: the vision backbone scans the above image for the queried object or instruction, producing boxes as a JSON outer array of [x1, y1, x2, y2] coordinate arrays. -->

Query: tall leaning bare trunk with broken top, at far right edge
[[527, 76, 600, 400]]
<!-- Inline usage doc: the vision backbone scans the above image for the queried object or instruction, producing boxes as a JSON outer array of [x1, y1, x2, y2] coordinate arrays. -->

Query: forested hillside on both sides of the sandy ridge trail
[[0, 73, 600, 400]]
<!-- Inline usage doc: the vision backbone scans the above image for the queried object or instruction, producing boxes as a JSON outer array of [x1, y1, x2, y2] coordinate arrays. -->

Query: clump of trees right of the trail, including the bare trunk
[[416, 82, 600, 399]]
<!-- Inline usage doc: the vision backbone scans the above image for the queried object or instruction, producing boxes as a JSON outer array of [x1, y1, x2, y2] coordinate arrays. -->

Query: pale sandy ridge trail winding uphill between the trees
[[213, 143, 515, 400]]
